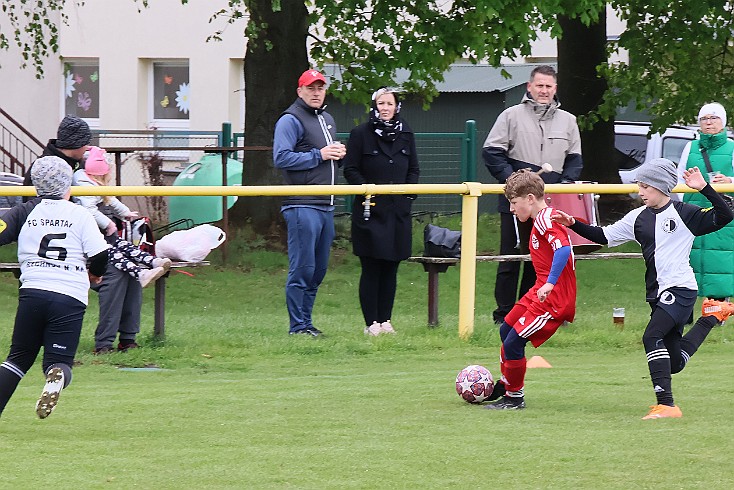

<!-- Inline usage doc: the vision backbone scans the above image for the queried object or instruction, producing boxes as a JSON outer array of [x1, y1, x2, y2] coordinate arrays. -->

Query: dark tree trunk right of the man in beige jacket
[[558, 16, 629, 221]]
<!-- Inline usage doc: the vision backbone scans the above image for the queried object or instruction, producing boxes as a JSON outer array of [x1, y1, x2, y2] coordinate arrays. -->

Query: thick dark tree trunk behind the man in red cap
[[230, 0, 308, 240]]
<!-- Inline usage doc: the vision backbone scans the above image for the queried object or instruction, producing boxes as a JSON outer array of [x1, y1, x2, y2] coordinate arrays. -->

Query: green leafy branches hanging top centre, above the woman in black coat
[[204, 0, 605, 104]]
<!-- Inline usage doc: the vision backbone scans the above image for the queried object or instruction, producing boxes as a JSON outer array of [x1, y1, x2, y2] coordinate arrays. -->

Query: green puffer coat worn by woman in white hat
[[683, 131, 734, 298]]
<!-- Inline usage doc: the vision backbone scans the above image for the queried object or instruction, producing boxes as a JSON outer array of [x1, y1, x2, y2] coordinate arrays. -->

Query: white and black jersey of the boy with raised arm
[[603, 185, 732, 301]]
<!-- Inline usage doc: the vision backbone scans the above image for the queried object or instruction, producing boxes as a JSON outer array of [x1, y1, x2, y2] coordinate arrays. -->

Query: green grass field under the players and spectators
[[0, 218, 734, 489]]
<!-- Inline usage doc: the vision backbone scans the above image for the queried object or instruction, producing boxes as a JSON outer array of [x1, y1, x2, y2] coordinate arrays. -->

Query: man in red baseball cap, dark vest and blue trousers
[[273, 69, 346, 337]]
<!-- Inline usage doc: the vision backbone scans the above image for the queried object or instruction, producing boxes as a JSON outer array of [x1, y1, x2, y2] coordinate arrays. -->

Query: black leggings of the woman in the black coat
[[359, 257, 400, 326]]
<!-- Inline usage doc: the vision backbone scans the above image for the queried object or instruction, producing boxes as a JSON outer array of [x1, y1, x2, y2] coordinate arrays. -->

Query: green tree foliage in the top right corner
[[600, 0, 734, 129]]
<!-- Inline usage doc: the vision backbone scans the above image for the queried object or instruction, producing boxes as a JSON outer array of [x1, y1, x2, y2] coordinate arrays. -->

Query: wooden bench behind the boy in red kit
[[408, 252, 642, 327]]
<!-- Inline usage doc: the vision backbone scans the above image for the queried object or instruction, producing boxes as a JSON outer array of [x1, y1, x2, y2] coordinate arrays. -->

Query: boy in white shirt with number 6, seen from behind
[[0, 156, 109, 419]]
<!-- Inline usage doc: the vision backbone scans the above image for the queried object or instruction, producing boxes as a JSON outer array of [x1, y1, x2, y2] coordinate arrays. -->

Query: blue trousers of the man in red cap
[[283, 207, 335, 332]]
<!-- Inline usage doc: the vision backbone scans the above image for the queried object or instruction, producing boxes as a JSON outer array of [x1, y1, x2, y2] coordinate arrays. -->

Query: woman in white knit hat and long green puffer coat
[[678, 102, 734, 300]]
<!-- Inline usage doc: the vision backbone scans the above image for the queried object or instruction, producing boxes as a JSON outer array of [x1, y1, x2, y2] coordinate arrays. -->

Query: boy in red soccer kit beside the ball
[[485, 170, 576, 410]]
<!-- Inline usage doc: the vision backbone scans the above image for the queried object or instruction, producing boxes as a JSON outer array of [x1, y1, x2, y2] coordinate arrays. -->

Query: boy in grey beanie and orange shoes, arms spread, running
[[553, 158, 734, 420]]
